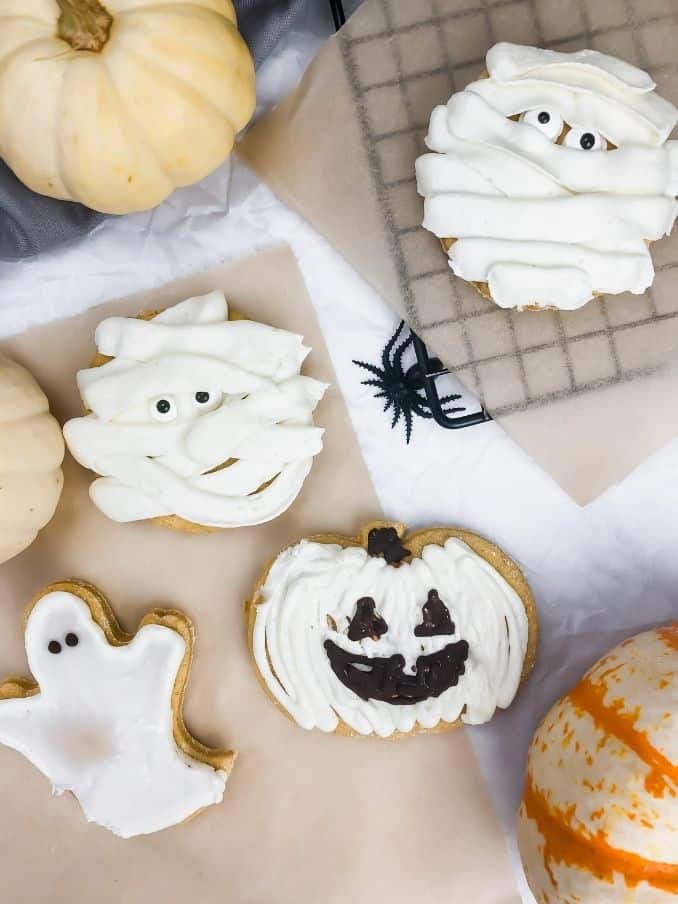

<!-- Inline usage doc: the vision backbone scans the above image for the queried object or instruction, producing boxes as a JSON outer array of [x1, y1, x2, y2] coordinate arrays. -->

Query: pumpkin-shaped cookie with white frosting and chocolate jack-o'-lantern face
[[246, 522, 537, 738]]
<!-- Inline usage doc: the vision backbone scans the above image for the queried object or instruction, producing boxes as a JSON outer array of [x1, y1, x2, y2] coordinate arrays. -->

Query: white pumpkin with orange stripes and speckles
[[518, 622, 678, 904]]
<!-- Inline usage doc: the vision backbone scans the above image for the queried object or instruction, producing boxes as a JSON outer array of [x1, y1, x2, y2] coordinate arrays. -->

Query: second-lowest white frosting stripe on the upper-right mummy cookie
[[448, 238, 654, 298]]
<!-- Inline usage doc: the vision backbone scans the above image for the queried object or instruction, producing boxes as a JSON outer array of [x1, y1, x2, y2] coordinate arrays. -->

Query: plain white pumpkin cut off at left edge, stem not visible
[[0, 355, 64, 562]]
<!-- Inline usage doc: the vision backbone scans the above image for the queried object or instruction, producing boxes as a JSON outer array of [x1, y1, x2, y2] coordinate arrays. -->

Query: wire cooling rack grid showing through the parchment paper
[[340, 0, 678, 415]]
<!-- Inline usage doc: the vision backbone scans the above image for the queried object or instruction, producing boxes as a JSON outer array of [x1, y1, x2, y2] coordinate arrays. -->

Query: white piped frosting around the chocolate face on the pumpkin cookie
[[253, 539, 528, 737]]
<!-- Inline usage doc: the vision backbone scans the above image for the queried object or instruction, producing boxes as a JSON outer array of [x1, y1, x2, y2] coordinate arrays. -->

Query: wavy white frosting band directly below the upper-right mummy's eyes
[[446, 91, 678, 197]]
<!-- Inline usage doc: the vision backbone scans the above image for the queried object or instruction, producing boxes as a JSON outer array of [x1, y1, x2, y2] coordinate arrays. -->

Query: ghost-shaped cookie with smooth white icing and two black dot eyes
[[0, 581, 234, 838]]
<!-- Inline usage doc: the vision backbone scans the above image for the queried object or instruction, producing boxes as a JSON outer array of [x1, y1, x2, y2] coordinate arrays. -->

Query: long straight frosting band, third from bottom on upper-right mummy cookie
[[424, 192, 676, 247]]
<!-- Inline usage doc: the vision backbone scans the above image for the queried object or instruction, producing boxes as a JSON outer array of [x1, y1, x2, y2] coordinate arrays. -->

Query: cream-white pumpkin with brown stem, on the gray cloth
[[0, 0, 255, 214]]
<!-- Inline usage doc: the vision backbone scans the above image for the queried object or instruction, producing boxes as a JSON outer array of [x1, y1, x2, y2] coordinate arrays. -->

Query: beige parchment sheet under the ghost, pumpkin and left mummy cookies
[[0, 250, 518, 904]]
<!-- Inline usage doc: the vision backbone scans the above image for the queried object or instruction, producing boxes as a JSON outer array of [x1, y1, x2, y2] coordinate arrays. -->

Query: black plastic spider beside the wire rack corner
[[353, 321, 466, 443]]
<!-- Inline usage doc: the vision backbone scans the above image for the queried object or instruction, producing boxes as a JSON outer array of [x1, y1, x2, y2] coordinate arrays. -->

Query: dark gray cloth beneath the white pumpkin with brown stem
[[0, 0, 314, 261]]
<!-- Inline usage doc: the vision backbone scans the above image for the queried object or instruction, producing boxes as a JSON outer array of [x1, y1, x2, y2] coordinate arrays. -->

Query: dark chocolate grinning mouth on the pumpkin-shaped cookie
[[324, 640, 468, 706]]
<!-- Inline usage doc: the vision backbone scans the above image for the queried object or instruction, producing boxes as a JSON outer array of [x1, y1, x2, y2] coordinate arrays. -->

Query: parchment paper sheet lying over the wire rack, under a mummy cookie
[[240, 0, 678, 503]]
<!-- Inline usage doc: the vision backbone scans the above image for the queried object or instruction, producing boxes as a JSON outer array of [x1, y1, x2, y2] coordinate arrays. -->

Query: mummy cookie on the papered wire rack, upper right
[[416, 43, 678, 310]]
